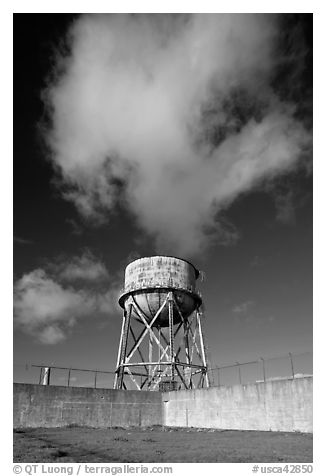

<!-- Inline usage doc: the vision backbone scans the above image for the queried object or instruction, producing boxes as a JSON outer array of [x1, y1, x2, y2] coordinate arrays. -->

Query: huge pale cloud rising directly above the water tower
[[43, 14, 311, 255]]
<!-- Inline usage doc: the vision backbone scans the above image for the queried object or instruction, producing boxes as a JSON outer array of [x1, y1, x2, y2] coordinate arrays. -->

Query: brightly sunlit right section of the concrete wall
[[163, 377, 312, 432]]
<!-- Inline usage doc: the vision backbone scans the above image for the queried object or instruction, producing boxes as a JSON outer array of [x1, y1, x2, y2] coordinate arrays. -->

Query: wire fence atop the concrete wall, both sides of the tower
[[14, 352, 313, 388]]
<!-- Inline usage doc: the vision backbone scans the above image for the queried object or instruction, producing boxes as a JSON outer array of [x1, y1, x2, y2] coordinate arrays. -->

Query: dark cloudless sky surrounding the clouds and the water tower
[[14, 14, 312, 386]]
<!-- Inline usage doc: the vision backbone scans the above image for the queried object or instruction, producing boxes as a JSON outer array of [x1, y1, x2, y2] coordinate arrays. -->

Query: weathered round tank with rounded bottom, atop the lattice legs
[[119, 256, 201, 327]]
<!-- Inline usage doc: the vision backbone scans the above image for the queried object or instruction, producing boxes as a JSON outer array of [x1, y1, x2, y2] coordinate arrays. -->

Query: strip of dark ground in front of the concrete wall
[[14, 427, 312, 463]]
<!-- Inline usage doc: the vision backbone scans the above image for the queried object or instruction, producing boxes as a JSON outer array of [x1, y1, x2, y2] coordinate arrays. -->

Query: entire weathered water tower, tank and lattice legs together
[[114, 256, 209, 391]]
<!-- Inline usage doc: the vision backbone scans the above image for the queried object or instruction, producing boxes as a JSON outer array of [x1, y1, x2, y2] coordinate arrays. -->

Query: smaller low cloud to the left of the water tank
[[14, 255, 117, 344]]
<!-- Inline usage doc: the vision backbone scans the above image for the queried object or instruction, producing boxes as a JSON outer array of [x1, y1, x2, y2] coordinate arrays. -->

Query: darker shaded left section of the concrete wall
[[14, 383, 162, 428]]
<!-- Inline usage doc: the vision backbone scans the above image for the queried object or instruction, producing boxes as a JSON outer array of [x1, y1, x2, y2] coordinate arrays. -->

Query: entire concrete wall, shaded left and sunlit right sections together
[[14, 377, 312, 432]]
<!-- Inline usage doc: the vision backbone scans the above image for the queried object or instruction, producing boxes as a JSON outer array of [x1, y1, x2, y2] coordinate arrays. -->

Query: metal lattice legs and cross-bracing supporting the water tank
[[114, 291, 209, 390]]
